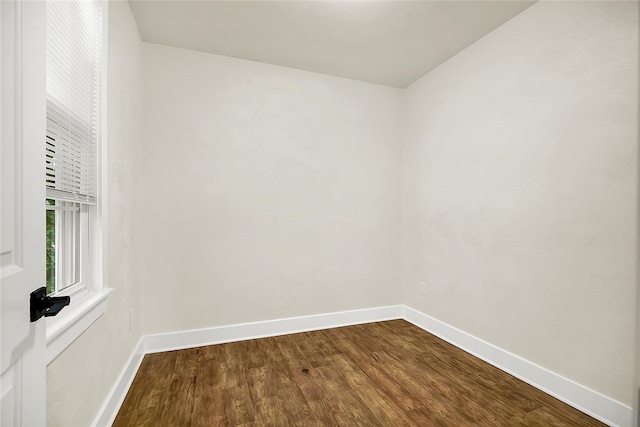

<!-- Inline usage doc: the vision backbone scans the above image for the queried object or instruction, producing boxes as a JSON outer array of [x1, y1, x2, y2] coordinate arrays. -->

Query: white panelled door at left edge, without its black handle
[[0, 0, 46, 427]]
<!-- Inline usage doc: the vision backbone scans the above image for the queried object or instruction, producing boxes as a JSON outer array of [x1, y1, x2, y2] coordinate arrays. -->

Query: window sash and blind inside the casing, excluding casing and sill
[[44, 0, 103, 295]]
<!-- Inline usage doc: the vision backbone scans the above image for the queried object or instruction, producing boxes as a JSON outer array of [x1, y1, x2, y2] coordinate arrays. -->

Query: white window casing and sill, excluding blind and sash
[[43, 0, 112, 364]]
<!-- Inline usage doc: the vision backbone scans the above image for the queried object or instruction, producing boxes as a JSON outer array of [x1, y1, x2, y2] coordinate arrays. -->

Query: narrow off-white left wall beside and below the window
[[47, 2, 142, 427]]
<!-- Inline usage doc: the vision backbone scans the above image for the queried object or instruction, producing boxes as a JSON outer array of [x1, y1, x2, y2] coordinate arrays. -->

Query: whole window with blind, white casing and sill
[[43, 0, 110, 363]]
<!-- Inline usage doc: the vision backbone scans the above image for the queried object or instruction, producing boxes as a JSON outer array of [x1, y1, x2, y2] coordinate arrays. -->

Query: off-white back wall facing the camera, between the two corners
[[142, 44, 401, 333]]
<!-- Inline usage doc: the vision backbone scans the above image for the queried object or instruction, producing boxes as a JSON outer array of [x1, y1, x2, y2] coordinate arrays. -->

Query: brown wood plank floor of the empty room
[[114, 320, 604, 427]]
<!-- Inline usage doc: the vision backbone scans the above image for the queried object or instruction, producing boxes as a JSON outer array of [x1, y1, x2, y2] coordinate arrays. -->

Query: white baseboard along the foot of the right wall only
[[402, 306, 633, 427]]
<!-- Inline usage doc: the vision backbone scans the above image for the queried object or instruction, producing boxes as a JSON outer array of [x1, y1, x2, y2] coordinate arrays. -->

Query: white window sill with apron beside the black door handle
[[46, 288, 112, 365]]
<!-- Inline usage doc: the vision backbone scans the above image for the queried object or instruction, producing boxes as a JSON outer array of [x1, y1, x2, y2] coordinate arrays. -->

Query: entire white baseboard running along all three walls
[[93, 305, 633, 427]]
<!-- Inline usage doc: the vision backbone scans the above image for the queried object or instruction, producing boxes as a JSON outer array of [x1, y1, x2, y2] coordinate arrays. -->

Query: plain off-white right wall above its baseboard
[[403, 2, 638, 404]]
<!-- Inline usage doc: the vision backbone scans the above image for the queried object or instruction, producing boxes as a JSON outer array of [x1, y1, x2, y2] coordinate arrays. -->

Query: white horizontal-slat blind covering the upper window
[[45, 0, 102, 204]]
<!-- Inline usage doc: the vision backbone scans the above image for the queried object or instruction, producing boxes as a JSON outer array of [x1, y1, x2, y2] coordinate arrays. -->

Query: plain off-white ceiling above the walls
[[129, 0, 535, 88]]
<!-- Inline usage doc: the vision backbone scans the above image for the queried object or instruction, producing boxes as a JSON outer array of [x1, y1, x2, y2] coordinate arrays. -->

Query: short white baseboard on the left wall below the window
[[92, 337, 145, 427]]
